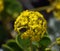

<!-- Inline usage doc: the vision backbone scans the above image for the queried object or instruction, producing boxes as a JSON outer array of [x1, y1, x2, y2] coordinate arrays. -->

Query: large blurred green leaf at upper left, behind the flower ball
[[5, 0, 23, 17]]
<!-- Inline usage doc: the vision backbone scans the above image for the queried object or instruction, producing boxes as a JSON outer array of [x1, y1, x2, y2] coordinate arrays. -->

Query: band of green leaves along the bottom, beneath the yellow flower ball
[[3, 31, 51, 51]]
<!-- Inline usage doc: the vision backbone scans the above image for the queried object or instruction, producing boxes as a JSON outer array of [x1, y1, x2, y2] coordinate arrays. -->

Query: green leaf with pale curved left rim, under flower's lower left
[[16, 35, 30, 49]]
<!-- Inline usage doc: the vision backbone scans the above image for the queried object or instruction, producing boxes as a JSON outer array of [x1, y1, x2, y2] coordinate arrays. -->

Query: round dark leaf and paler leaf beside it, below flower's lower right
[[32, 36, 51, 51]]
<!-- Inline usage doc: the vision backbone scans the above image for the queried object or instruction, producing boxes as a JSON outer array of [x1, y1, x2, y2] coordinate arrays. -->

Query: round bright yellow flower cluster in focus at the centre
[[14, 10, 47, 41]]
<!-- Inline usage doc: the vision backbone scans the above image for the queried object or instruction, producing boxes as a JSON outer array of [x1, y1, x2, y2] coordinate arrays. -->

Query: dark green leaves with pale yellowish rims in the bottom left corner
[[2, 40, 23, 51]]
